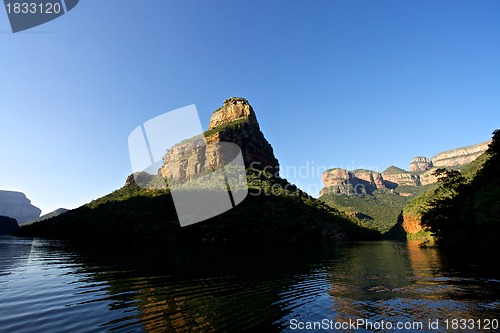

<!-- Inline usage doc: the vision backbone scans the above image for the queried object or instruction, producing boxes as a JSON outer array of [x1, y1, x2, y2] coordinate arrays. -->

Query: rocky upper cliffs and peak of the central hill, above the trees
[[160, 97, 279, 181]]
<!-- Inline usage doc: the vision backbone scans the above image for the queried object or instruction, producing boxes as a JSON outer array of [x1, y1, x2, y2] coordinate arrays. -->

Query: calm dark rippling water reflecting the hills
[[0, 237, 500, 332]]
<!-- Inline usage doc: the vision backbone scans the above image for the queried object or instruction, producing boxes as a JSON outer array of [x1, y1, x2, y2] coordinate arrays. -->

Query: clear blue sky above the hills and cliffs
[[0, 0, 500, 213]]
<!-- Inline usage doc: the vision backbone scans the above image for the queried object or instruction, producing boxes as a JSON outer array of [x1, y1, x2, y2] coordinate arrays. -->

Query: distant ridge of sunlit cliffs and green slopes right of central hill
[[319, 141, 491, 238]]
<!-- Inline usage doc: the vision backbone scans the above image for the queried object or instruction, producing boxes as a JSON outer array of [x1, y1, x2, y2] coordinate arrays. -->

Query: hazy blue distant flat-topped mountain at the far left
[[0, 191, 42, 224]]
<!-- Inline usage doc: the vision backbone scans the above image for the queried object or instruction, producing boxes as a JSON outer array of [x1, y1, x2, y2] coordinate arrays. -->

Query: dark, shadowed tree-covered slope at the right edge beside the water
[[422, 130, 500, 254]]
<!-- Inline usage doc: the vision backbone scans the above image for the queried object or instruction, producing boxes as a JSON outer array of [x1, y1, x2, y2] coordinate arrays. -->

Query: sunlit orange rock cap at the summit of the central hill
[[208, 97, 259, 130]]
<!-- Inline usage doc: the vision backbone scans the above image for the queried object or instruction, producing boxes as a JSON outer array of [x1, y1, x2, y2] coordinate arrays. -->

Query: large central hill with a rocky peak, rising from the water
[[17, 98, 375, 242]]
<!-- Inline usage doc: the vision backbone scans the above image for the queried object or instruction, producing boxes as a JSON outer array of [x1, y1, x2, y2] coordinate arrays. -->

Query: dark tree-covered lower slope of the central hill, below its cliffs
[[17, 169, 374, 242]]
